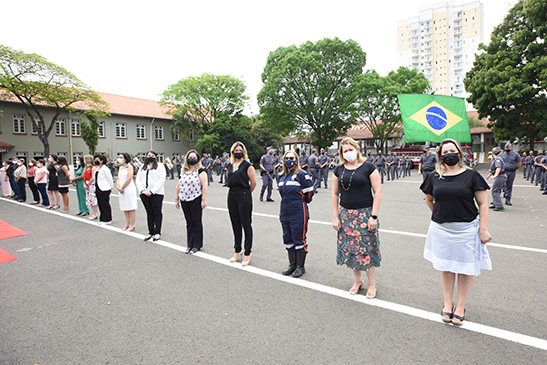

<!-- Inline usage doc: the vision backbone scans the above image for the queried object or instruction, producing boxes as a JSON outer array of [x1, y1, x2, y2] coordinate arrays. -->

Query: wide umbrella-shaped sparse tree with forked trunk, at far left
[[0, 45, 107, 156]]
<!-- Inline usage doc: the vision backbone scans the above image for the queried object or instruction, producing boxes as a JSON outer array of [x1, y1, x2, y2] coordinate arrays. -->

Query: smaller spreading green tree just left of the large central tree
[[161, 73, 249, 151]]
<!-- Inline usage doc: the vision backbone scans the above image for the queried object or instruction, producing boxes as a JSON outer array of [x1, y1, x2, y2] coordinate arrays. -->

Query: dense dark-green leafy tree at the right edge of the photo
[[464, 0, 547, 148]]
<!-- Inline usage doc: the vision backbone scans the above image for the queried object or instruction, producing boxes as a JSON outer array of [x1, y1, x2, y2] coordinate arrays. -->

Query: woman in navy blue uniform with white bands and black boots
[[279, 151, 313, 278]]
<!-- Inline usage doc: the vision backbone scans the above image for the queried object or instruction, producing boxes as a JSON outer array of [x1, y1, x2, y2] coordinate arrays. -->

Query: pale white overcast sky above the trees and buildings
[[0, 0, 517, 115]]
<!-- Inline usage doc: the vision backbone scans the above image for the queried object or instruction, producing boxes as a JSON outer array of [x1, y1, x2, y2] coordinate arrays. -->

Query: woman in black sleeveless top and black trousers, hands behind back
[[226, 142, 256, 266]]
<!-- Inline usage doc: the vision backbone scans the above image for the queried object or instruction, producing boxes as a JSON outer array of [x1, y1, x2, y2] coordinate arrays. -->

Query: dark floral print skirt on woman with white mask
[[336, 207, 382, 271]]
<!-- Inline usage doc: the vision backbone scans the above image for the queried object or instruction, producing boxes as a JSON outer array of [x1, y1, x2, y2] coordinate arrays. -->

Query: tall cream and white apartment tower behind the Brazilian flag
[[397, 1, 484, 97]]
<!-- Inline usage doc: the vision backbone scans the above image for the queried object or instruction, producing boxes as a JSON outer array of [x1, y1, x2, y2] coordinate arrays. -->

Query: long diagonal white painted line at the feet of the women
[[1, 198, 547, 351]]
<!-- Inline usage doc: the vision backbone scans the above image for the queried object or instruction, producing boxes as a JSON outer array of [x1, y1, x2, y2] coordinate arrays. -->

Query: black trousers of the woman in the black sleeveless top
[[228, 189, 253, 256]]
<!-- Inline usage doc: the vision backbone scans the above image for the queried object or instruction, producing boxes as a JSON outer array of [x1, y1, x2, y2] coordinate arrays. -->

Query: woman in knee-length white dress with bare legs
[[116, 152, 137, 231]]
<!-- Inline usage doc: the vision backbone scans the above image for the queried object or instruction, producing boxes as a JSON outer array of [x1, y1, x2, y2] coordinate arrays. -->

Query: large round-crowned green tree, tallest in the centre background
[[258, 38, 366, 148]]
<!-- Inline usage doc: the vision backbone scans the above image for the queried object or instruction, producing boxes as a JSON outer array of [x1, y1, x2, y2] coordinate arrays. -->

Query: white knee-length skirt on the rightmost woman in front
[[424, 217, 492, 276]]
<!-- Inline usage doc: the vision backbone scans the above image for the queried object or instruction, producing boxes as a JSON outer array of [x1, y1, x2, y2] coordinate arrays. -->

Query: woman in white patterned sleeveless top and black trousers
[[175, 150, 209, 254]]
